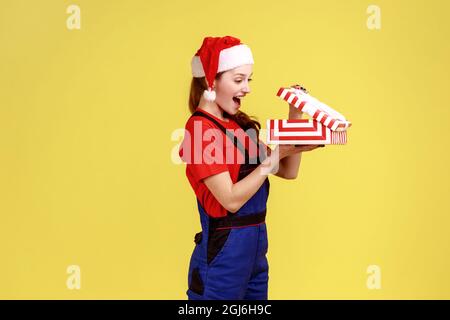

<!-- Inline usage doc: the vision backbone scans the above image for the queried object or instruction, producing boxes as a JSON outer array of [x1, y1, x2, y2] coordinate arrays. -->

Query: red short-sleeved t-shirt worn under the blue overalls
[[179, 108, 268, 217]]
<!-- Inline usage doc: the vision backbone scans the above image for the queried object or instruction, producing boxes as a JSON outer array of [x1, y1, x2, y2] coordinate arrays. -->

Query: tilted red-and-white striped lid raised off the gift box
[[277, 87, 352, 131]]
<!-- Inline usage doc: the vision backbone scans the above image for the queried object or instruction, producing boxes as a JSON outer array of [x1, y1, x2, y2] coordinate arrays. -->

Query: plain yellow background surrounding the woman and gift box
[[0, 0, 450, 299]]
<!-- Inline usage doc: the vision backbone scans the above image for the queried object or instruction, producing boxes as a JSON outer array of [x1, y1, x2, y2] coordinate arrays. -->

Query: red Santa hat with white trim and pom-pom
[[191, 36, 254, 101]]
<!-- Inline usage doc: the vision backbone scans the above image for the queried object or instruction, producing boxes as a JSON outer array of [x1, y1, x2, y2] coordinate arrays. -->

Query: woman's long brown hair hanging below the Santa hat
[[189, 72, 261, 137]]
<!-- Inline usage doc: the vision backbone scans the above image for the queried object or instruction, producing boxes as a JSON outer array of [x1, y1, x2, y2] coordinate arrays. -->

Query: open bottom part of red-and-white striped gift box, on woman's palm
[[267, 119, 347, 144]]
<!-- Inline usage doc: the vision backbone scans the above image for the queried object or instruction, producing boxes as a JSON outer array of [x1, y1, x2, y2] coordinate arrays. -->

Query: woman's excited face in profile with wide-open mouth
[[215, 64, 253, 115]]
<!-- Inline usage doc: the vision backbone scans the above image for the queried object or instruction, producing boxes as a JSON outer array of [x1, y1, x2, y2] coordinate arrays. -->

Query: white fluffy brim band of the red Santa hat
[[191, 44, 254, 78]]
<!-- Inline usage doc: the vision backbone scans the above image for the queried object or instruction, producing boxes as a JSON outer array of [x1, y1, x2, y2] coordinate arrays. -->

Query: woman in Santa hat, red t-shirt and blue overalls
[[180, 36, 324, 300]]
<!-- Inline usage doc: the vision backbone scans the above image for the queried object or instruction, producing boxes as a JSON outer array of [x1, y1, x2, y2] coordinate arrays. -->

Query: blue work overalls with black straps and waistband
[[186, 111, 270, 300]]
